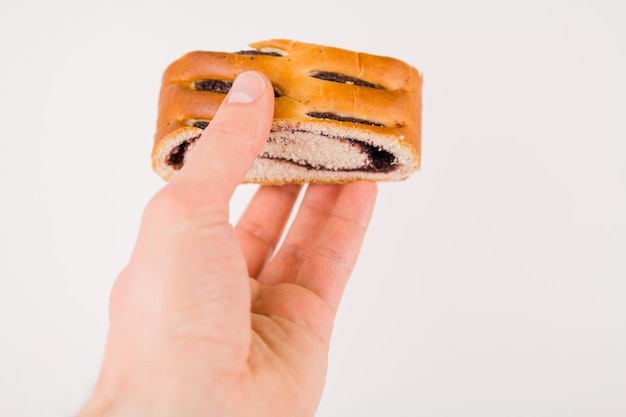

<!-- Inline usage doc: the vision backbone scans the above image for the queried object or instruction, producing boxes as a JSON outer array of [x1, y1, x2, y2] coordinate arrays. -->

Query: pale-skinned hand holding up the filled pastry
[[78, 72, 376, 417]]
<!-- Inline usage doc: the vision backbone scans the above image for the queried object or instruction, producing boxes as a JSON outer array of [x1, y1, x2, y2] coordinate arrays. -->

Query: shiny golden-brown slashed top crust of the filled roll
[[152, 39, 422, 182]]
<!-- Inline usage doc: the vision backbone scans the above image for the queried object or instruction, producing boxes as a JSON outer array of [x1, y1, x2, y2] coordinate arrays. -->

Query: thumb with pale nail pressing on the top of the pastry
[[172, 71, 274, 204]]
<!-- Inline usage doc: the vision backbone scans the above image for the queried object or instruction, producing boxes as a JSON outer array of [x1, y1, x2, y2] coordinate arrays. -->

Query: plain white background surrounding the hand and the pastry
[[0, 0, 626, 417]]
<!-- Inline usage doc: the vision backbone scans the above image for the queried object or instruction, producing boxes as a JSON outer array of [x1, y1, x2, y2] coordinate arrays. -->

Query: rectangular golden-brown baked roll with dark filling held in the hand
[[152, 39, 422, 184]]
